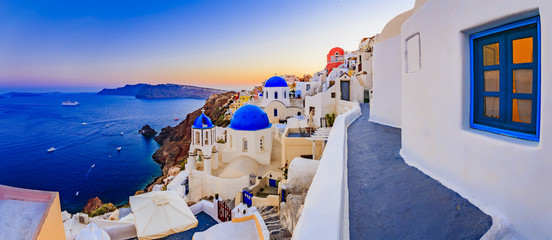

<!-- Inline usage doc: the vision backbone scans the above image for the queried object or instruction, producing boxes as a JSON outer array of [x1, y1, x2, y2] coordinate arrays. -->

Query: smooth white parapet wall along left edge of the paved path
[[293, 104, 361, 239]]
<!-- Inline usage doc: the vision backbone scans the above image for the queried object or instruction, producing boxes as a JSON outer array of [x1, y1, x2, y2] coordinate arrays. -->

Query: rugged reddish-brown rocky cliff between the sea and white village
[[147, 92, 237, 191]]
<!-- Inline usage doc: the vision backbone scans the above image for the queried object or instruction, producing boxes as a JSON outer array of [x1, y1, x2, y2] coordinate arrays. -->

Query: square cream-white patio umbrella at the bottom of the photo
[[129, 191, 198, 240]]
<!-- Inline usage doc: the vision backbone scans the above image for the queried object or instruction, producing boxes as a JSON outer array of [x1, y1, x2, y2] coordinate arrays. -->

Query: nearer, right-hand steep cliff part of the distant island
[[136, 84, 224, 99]]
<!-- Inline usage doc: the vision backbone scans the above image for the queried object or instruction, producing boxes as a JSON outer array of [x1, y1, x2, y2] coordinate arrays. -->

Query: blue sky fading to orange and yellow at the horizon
[[0, 0, 414, 91]]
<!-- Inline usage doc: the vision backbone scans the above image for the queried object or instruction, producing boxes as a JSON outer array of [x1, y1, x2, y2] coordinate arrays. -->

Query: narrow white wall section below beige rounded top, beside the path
[[370, 35, 404, 127]]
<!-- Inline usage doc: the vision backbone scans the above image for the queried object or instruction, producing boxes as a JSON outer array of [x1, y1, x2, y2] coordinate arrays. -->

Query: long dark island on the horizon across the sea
[[98, 83, 225, 99]]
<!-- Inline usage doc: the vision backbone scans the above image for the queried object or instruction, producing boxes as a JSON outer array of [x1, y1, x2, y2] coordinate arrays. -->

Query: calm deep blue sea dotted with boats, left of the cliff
[[0, 93, 205, 212]]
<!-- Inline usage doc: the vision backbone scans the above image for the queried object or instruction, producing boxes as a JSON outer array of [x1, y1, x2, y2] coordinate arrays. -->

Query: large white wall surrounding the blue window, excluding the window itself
[[402, 0, 552, 239]]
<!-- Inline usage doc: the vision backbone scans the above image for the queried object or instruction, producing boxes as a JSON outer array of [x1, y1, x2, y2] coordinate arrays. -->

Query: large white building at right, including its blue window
[[370, 0, 552, 239]]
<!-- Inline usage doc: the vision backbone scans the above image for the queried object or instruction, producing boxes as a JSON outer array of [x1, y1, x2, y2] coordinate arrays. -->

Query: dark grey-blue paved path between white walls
[[347, 104, 492, 240]]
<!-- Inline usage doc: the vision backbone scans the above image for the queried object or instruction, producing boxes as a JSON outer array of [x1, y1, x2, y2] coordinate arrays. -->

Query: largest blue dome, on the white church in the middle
[[228, 104, 272, 131]]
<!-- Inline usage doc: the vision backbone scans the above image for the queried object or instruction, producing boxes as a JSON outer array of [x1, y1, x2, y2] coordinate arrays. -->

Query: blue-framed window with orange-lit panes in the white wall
[[470, 17, 540, 141]]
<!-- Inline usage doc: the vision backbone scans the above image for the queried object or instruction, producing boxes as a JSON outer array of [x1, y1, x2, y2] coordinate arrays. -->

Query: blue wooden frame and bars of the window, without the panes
[[470, 16, 541, 141]]
